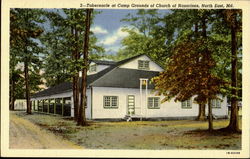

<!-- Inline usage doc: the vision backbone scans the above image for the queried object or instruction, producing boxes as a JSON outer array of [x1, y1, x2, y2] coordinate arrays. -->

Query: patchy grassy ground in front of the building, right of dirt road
[[12, 112, 241, 150]]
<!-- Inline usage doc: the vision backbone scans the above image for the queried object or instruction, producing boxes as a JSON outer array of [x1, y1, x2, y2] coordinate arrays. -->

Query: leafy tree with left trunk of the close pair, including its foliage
[[42, 9, 104, 120]]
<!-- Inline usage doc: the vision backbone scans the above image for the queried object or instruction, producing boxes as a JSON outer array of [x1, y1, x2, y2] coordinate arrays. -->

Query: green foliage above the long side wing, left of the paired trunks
[[40, 10, 71, 87]]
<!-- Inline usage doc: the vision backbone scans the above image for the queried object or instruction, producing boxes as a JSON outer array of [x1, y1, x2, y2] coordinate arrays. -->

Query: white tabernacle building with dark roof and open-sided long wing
[[31, 54, 228, 120]]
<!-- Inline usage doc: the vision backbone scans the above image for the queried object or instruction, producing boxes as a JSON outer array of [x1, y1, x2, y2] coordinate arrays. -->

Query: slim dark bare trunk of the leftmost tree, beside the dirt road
[[24, 59, 31, 114]]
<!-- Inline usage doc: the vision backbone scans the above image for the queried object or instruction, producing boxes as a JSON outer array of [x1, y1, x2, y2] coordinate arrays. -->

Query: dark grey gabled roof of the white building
[[32, 54, 162, 98]]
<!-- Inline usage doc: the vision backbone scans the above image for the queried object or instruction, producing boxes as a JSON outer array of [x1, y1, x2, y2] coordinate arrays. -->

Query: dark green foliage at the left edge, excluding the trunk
[[10, 9, 43, 98]]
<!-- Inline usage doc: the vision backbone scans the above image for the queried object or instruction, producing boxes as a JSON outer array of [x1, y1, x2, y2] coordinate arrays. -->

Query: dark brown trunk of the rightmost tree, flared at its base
[[227, 14, 240, 132]]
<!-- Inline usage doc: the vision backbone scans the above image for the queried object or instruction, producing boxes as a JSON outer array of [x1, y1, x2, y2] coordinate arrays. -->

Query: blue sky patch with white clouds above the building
[[91, 9, 167, 54]]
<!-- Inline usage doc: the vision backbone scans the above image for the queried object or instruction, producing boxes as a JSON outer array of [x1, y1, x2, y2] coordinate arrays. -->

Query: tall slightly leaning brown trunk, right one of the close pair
[[77, 9, 93, 126]]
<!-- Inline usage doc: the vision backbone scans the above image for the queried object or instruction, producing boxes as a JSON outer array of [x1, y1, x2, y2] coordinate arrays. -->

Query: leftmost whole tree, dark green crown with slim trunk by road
[[10, 9, 43, 114]]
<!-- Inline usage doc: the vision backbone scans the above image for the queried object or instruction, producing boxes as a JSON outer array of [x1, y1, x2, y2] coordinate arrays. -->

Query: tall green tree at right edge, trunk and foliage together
[[207, 10, 242, 132]]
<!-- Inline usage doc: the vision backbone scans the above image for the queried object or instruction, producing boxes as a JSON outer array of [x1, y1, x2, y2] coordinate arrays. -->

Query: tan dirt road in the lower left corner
[[9, 113, 83, 149]]
